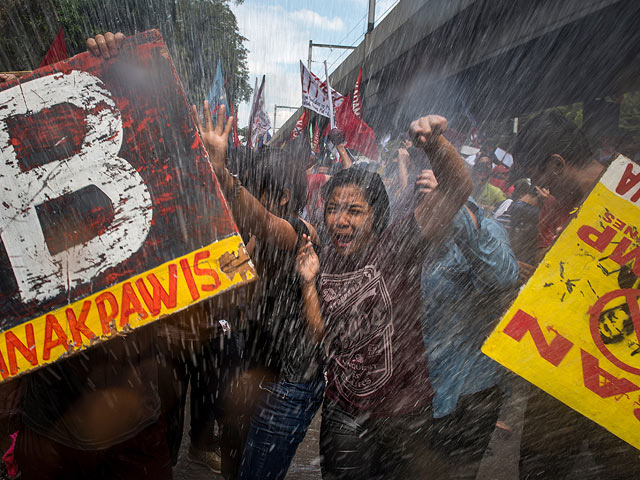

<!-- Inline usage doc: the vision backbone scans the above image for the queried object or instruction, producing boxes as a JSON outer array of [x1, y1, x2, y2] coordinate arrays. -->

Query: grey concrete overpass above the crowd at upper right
[[276, 0, 640, 140]]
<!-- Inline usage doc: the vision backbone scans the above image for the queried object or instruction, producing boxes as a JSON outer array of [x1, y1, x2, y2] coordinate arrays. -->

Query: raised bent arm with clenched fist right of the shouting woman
[[409, 115, 471, 239]]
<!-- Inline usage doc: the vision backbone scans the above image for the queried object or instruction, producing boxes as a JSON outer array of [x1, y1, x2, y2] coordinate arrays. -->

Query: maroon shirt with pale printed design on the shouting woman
[[318, 216, 433, 416]]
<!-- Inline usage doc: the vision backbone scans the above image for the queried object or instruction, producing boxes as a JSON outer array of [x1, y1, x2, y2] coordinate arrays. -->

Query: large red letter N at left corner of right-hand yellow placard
[[504, 310, 573, 367]]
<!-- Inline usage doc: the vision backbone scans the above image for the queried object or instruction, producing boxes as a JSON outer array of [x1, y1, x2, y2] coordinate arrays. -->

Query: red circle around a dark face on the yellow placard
[[589, 288, 640, 375]]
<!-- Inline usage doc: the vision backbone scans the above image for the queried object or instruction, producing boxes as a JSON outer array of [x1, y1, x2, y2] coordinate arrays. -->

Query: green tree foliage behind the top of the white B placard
[[0, 0, 251, 103]]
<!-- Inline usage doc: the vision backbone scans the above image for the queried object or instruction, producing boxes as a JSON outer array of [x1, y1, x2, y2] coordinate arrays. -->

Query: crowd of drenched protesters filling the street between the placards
[[0, 21, 640, 480]]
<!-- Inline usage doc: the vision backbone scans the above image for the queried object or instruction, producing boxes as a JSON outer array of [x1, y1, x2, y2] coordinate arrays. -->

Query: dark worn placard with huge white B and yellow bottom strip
[[0, 31, 255, 380]]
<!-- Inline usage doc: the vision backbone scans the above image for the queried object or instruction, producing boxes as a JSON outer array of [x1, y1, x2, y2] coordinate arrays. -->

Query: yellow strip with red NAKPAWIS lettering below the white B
[[0, 235, 255, 379]]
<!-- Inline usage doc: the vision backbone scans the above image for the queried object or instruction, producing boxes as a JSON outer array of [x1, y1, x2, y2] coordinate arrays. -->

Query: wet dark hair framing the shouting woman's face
[[322, 167, 389, 235]]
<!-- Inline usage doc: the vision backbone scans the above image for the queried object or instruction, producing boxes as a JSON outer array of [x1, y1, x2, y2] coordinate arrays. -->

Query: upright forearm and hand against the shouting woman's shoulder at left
[[296, 235, 324, 342]]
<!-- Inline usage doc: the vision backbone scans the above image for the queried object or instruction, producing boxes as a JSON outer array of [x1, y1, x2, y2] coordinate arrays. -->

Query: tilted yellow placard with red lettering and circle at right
[[482, 156, 640, 448]]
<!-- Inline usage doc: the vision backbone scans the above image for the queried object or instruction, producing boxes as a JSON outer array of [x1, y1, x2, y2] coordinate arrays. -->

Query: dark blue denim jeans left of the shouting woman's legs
[[238, 378, 324, 480]]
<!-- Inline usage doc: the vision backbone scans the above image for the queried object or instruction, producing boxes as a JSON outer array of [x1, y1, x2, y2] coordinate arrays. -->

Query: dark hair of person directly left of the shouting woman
[[245, 146, 307, 215]]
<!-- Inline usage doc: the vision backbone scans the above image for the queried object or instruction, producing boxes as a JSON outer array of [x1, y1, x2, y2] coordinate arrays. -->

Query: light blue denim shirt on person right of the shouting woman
[[421, 198, 519, 418]]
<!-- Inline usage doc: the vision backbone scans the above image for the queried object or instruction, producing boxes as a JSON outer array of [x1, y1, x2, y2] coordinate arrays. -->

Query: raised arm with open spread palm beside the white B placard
[[192, 100, 298, 251]]
